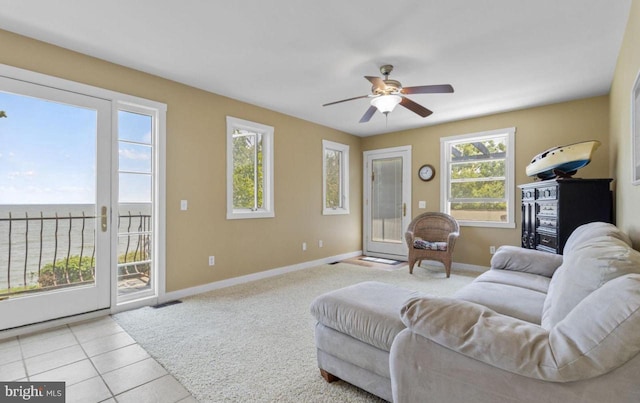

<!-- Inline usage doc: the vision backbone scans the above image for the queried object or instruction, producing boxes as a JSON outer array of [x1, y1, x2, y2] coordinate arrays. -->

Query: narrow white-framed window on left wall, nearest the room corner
[[322, 140, 349, 215]]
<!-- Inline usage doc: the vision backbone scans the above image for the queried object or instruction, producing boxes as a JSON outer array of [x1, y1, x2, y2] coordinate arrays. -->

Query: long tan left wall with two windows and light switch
[[0, 31, 362, 291]]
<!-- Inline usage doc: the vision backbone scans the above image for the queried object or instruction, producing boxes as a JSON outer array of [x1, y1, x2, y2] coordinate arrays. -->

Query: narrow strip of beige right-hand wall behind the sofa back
[[610, 0, 640, 249]]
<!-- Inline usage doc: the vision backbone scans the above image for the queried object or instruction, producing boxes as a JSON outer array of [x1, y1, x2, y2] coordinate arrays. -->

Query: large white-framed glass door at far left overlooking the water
[[0, 77, 112, 330]]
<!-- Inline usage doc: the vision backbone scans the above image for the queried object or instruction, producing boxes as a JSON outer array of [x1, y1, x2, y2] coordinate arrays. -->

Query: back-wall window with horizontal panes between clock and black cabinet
[[440, 127, 515, 228]]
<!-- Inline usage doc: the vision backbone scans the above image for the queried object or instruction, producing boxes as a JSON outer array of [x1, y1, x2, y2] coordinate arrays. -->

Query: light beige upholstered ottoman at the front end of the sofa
[[311, 281, 417, 401]]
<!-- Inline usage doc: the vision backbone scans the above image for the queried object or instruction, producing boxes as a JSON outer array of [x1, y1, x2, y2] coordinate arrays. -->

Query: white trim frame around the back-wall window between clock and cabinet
[[440, 127, 516, 228]]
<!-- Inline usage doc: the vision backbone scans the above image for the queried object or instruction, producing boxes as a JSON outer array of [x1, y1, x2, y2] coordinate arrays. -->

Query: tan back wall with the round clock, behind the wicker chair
[[362, 96, 609, 266]]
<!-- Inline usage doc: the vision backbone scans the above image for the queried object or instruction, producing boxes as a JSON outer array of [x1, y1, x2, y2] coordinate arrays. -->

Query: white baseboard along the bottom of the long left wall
[[158, 251, 362, 304]]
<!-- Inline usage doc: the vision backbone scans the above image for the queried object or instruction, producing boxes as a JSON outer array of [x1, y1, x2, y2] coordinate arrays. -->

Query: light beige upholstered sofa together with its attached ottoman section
[[311, 223, 640, 403]]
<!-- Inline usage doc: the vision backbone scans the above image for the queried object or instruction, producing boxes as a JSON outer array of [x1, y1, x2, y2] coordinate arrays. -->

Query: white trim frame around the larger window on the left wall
[[227, 116, 275, 220]]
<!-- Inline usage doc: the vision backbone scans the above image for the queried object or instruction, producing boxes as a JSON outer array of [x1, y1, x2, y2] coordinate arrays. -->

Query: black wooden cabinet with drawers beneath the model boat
[[518, 178, 613, 254]]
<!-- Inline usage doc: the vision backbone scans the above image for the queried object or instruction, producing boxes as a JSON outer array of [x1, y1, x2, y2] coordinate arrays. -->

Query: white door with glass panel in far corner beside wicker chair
[[363, 146, 411, 259]]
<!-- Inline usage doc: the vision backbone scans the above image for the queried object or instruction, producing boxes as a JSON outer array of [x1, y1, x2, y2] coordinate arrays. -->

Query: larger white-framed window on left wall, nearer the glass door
[[227, 116, 274, 219]]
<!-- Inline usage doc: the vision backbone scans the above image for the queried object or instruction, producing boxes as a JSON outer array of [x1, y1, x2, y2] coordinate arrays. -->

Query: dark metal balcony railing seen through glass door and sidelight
[[0, 212, 151, 299]]
